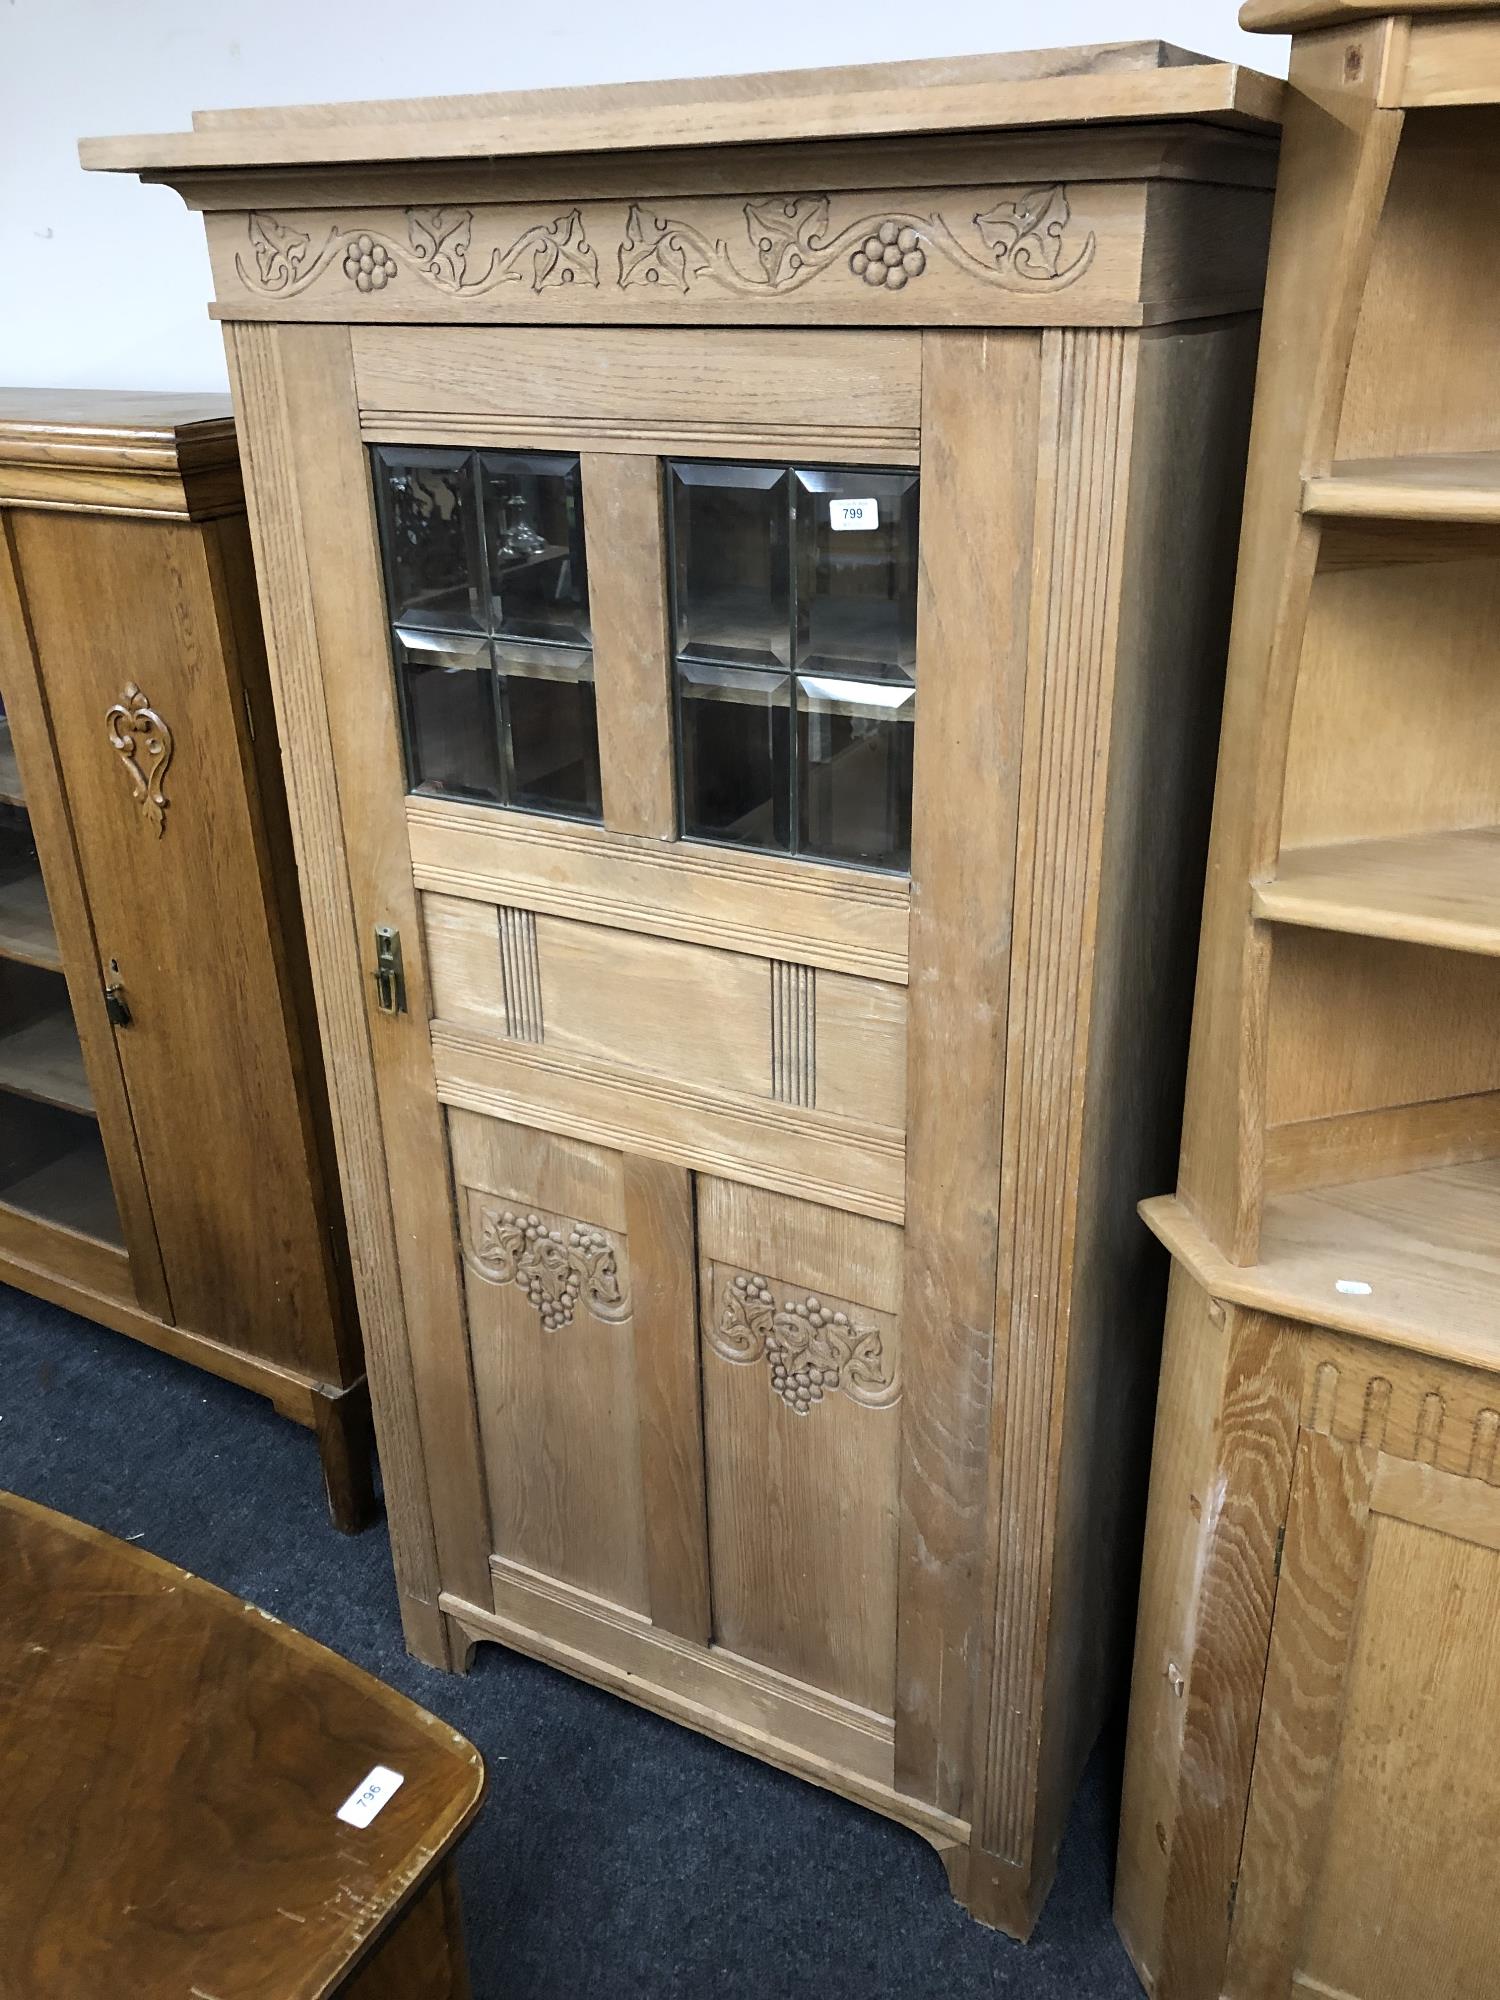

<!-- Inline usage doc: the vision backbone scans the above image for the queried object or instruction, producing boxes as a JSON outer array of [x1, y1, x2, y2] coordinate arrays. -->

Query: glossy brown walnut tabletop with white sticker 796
[[0, 1494, 484, 2000]]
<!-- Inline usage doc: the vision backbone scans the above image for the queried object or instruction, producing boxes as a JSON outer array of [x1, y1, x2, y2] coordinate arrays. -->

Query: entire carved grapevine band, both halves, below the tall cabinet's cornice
[[234, 184, 1096, 298]]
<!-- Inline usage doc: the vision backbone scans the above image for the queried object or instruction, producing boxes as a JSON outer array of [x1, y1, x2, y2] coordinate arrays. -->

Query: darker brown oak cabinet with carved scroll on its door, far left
[[0, 390, 372, 1528]]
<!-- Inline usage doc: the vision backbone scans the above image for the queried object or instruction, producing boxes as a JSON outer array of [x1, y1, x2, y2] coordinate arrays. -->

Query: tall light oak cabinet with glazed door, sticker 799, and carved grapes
[[84, 44, 1280, 1934]]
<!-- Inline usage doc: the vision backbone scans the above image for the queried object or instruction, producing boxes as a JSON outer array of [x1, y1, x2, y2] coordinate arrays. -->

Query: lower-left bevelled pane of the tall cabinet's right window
[[678, 662, 792, 850]]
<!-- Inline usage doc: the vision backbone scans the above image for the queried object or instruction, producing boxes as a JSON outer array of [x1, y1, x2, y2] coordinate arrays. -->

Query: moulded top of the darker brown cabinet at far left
[[0, 388, 234, 464]]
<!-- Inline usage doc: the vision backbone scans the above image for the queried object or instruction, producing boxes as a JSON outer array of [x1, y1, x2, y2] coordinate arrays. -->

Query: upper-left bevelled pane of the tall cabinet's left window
[[374, 444, 482, 632]]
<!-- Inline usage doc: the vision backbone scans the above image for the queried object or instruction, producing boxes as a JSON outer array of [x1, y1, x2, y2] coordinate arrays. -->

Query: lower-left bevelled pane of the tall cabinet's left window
[[394, 628, 504, 806]]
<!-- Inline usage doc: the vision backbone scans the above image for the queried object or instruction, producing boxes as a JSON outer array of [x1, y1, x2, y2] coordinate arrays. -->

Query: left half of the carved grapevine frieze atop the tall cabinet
[[234, 208, 598, 298]]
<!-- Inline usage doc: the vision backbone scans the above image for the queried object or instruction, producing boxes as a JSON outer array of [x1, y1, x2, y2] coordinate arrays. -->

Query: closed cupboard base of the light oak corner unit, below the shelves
[[1116, 1272, 1500, 2000]]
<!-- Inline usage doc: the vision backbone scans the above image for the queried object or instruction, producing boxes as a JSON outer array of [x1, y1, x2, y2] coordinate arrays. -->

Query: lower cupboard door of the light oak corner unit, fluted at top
[[1224, 1376, 1500, 2000]]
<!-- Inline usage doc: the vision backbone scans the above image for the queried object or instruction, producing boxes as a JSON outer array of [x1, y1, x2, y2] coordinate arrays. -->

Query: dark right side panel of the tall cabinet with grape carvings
[[1016, 320, 1258, 1892]]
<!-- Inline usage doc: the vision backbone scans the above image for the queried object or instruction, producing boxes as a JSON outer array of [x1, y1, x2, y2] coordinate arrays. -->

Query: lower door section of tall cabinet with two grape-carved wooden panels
[[448, 1110, 916, 1822]]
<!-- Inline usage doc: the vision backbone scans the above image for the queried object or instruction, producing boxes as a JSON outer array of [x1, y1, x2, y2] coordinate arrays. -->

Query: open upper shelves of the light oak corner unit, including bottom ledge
[[1144, 6, 1500, 1352]]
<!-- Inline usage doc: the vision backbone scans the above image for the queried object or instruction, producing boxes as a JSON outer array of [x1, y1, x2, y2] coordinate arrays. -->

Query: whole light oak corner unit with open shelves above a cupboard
[[1116, 0, 1500, 2000]]
